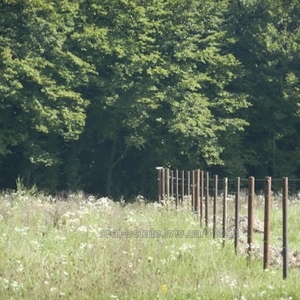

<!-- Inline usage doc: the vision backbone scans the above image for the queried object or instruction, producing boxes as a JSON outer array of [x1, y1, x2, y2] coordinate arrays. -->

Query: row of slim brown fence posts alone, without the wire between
[[156, 167, 288, 279]]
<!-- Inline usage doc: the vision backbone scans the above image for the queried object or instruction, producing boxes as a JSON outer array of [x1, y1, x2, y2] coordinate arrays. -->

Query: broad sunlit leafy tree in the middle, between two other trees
[[71, 0, 247, 194]]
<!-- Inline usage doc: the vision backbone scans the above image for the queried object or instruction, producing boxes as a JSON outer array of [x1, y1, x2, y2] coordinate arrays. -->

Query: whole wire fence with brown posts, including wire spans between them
[[157, 168, 300, 279]]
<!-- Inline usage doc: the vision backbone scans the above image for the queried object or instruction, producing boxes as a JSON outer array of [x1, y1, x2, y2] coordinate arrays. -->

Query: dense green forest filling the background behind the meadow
[[0, 0, 300, 198]]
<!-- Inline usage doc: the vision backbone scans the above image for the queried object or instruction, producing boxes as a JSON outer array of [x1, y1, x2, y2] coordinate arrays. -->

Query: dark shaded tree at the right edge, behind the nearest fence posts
[[228, 0, 300, 177]]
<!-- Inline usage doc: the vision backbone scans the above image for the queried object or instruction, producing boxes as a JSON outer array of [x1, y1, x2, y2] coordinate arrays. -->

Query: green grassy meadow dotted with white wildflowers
[[0, 191, 300, 300]]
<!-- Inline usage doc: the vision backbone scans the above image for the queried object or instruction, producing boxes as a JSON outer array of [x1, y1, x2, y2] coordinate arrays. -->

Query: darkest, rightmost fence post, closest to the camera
[[282, 177, 289, 279]]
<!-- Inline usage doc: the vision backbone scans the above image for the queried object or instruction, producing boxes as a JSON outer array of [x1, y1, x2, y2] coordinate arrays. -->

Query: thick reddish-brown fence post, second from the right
[[263, 177, 272, 270]]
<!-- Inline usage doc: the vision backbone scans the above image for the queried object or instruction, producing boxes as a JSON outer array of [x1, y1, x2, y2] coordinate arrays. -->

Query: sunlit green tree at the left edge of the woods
[[0, 0, 93, 188]]
